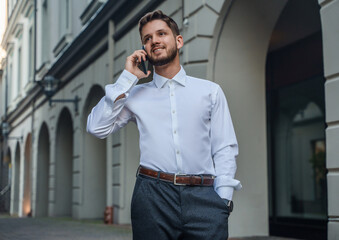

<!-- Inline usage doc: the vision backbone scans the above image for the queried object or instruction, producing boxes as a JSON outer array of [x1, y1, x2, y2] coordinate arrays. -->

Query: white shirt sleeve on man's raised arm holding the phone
[[87, 70, 138, 139]]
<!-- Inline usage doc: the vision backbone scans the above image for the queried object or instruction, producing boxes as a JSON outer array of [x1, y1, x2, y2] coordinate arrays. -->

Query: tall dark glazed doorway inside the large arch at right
[[266, 0, 327, 239]]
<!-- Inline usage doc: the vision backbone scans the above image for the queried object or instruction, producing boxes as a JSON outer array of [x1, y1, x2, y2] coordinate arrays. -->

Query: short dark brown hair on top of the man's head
[[139, 10, 180, 36]]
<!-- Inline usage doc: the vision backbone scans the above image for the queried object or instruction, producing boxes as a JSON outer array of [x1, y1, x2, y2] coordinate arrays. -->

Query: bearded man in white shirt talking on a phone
[[87, 10, 241, 240]]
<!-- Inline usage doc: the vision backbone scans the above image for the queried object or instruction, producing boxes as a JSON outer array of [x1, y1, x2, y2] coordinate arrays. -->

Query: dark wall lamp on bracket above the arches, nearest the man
[[38, 75, 80, 113]]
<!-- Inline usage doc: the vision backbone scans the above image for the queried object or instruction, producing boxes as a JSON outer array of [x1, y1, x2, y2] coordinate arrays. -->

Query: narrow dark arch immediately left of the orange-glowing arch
[[13, 142, 21, 215]]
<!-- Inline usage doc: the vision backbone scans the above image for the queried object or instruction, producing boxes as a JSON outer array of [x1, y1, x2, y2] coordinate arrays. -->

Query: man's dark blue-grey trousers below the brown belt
[[131, 175, 229, 240]]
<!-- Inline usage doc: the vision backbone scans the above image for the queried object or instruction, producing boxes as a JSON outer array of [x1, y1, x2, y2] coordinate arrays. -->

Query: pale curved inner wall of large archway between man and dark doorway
[[208, 0, 287, 236]]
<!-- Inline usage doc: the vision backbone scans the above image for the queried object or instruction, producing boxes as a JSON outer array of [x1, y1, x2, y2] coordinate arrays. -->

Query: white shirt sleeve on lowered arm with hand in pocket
[[211, 85, 242, 200]]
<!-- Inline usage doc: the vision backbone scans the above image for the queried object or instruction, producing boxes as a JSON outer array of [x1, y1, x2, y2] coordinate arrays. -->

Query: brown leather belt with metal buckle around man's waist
[[137, 166, 215, 186]]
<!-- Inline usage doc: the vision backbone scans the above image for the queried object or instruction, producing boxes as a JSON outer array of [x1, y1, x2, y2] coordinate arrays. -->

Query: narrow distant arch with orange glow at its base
[[22, 134, 32, 216]]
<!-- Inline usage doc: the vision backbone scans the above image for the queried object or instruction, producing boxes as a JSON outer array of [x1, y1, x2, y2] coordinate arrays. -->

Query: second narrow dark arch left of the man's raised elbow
[[54, 108, 73, 216]]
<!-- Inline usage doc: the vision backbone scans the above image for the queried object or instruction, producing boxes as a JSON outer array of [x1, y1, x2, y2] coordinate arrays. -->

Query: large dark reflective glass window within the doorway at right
[[272, 77, 327, 220]]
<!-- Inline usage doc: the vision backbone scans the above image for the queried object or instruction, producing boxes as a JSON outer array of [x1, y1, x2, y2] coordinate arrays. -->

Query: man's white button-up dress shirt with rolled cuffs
[[87, 67, 241, 200]]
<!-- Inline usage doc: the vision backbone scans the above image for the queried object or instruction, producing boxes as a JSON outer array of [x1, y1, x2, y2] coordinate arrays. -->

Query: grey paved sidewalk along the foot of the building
[[0, 215, 298, 240]]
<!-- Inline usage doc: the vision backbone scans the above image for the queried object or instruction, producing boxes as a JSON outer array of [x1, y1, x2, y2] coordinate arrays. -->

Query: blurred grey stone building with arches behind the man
[[0, 0, 339, 239]]
